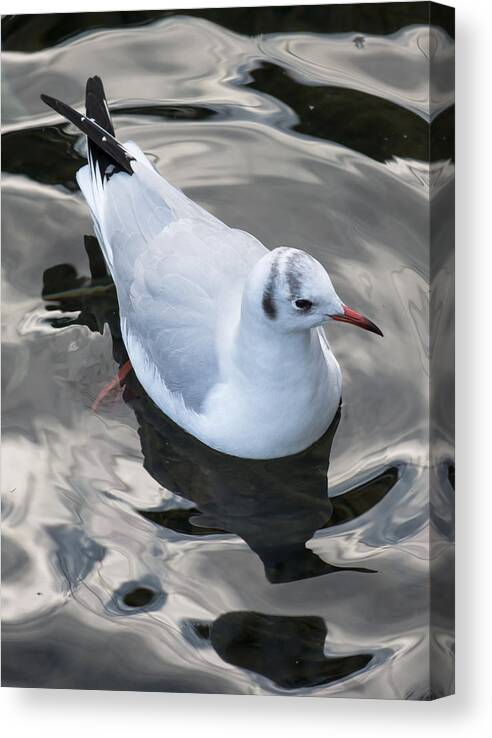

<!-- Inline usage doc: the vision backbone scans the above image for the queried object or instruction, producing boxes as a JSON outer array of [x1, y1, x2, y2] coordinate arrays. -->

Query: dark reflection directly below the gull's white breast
[[133, 392, 397, 583]]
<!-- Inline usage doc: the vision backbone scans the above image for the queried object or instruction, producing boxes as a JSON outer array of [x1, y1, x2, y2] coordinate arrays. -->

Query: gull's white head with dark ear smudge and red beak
[[244, 247, 383, 336]]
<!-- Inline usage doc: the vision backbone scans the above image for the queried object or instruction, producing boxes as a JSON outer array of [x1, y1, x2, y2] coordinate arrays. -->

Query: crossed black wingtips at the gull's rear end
[[41, 77, 134, 178]]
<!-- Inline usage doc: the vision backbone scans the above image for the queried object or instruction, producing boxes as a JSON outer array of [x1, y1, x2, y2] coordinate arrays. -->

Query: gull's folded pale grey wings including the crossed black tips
[[43, 82, 266, 413]]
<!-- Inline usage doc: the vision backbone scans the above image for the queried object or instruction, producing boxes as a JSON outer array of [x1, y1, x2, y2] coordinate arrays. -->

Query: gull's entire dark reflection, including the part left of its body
[[43, 237, 398, 583]]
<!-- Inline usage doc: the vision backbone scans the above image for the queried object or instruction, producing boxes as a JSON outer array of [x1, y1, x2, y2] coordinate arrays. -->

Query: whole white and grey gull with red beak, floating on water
[[41, 76, 383, 459]]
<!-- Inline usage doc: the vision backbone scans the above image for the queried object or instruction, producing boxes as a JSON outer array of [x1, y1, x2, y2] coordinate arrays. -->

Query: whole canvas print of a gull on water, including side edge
[[2, 2, 454, 700]]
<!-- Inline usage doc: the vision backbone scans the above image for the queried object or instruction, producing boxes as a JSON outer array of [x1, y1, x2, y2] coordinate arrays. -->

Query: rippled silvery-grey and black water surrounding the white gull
[[2, 3, 454, 699]]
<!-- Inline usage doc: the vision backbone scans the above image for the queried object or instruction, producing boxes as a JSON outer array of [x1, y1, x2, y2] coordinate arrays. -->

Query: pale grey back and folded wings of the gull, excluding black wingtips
[[97, 153, 266, 412]]
